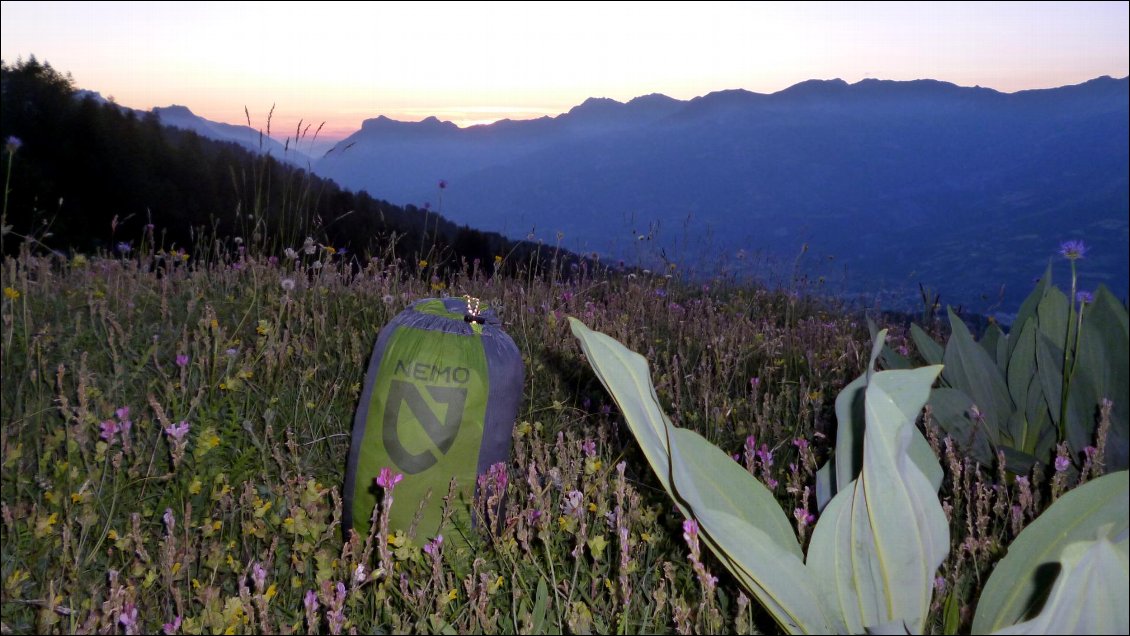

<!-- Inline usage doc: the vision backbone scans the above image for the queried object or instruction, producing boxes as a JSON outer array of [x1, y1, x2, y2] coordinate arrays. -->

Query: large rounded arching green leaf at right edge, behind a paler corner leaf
[[973, 470, 1130, 634]]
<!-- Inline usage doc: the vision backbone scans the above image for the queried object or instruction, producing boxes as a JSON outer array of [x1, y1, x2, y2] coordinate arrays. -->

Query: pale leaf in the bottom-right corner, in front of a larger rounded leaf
[[994, 534, 1130, 634]]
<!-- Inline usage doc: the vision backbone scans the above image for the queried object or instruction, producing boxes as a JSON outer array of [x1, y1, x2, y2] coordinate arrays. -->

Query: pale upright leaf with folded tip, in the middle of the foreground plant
[[808, 366, 949, 633]]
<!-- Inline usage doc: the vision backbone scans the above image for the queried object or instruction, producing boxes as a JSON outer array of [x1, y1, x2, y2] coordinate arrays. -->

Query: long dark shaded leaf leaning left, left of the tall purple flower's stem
[[942, 310, 1012, 430]]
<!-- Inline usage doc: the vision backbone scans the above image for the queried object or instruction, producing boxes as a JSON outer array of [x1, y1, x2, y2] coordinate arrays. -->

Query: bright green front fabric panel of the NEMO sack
[[353, 327, 489, 542]]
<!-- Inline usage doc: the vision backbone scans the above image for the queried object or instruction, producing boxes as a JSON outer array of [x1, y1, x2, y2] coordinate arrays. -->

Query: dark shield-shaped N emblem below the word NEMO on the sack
[[381, 380, 467, 474]]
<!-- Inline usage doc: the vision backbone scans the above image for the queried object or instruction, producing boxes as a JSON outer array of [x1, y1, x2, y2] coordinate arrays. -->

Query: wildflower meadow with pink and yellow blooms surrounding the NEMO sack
[[0, 236, 1102, 634]]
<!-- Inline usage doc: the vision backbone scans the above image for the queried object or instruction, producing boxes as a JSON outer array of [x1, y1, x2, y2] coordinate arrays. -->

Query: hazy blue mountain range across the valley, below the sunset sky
[[313, 77, 1130, 311]]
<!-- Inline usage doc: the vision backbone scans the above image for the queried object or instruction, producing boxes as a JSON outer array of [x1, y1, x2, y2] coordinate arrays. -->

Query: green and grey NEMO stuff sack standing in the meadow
[[342, 298, 524, 537]]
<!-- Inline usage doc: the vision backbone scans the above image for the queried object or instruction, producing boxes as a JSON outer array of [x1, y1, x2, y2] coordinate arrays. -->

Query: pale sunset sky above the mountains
[[0, 2, 1130, 141]]
